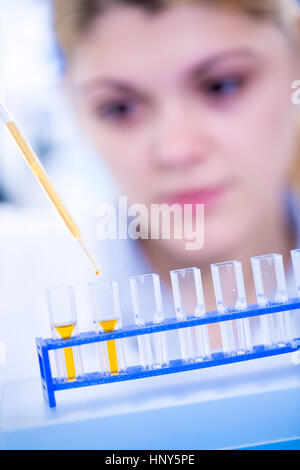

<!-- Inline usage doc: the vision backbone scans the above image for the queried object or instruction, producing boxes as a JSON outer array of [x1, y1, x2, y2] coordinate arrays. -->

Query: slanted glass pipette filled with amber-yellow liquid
[[0, 100, 102, 276]]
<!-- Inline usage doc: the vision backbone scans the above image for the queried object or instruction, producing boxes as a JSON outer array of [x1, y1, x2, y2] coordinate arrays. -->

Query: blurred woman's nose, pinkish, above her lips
[[154, 103, 208, 170]]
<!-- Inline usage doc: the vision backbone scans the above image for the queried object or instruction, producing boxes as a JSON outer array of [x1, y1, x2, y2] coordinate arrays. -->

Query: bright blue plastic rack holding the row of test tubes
[[36, 298, 300, 407]]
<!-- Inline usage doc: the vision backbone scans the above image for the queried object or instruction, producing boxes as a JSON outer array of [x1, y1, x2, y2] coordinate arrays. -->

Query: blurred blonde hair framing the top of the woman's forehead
[[53, 0, 300, 187]]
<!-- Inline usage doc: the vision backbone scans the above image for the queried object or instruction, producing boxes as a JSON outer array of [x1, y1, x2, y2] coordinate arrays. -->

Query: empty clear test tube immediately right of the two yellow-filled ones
[[129, 274, 169, 369]]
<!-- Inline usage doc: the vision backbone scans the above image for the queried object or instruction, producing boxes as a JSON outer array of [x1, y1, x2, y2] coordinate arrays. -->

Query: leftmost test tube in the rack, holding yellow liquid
[[46, 286, 82, 381]]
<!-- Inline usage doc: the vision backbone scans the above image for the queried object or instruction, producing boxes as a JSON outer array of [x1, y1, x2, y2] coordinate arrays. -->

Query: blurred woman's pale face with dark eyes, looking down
[[68, 4, 297, 261]]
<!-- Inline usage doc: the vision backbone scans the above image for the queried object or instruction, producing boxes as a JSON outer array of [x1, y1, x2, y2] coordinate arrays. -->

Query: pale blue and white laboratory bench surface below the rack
[[0, 354, 300, 450]]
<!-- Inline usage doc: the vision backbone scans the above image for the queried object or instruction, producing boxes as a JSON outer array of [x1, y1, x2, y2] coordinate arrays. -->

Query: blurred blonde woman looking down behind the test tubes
[[54, 0, 300, 330]]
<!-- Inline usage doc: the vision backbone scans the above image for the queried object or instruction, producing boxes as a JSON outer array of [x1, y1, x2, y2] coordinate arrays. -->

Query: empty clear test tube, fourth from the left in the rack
[[170, 268, 211, 361]]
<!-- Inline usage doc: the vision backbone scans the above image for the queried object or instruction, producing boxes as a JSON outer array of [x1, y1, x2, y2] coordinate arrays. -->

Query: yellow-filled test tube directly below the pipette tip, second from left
[[89, 280, 126, 375]]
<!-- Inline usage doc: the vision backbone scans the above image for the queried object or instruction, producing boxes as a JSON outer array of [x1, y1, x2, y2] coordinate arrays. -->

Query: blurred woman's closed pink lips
[[165, 185, 228, 211]]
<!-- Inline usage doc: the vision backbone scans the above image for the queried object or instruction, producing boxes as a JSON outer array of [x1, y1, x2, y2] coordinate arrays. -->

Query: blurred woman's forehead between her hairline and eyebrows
[[68, 4, 290, 90]]
